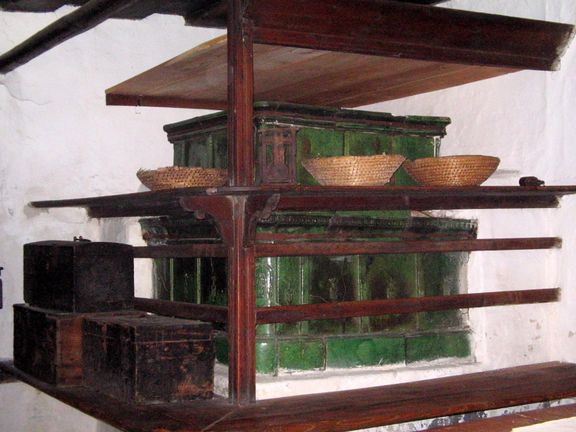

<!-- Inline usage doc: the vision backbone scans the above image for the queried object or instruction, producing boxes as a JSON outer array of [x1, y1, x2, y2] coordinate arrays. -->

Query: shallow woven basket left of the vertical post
[[136, 167, 228, 190]]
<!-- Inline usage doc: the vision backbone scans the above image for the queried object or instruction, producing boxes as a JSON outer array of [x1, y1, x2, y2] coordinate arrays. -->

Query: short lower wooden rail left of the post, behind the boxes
[[134, 297, 228, 323]]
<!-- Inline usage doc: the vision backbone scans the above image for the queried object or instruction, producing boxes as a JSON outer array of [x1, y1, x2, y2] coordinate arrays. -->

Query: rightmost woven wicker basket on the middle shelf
[[403, 155, 500, 186]]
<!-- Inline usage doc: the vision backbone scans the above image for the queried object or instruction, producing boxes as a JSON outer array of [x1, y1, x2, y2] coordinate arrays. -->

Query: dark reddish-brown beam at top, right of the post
[[252, 0, 574, 70]]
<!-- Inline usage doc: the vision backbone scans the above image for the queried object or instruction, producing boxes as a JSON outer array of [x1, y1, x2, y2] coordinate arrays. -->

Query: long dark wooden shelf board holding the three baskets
[[30, 186, 576, 217]]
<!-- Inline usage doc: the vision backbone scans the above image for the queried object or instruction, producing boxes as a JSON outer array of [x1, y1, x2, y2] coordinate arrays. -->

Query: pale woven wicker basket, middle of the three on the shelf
[[302, 155, 404, 186]]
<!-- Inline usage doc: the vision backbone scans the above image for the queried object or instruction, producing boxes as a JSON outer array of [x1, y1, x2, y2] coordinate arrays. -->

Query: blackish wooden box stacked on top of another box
[[24, 241, 134, 312]]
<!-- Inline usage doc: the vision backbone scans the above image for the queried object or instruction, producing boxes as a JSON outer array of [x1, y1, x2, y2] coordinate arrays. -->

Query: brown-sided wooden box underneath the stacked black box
[[14, 304, 143, 386]]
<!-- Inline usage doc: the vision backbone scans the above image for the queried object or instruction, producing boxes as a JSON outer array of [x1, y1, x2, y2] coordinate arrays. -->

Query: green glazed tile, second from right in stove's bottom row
[[326, 337, 404, 368]]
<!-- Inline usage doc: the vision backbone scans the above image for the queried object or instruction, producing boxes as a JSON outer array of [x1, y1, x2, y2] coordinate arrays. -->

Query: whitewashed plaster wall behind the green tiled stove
[[0, 0, 576, 432]]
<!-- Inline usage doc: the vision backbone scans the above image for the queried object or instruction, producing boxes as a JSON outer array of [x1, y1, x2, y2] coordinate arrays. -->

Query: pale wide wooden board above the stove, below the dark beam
[[106, 37, 519, 109]]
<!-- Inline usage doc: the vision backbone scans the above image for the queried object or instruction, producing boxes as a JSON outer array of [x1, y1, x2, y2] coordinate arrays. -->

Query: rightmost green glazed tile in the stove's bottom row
[[406, 332, 470, 362]]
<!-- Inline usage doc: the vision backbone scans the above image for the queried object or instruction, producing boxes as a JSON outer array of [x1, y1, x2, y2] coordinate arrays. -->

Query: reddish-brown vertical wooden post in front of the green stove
[[228, 0, 256, 404]]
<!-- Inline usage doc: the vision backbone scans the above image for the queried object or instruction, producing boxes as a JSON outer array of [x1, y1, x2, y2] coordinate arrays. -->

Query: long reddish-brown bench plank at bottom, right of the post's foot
[[213, 363, 576, 432]]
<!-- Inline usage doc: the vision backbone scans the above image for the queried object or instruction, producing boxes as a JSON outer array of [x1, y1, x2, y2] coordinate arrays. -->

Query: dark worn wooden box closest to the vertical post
[[83, 315, 214, 403]]
